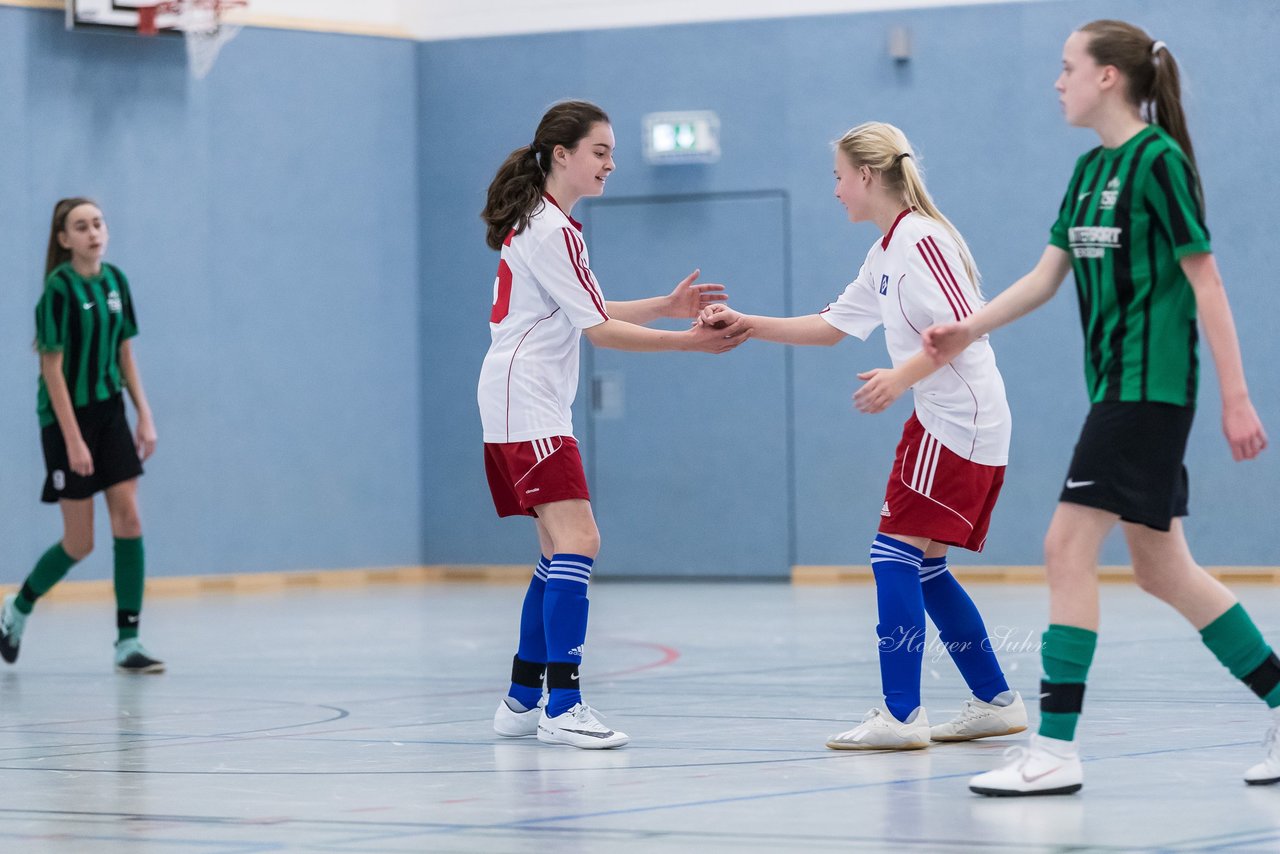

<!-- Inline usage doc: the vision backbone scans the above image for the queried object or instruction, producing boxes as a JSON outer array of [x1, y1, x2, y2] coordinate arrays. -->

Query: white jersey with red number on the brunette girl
[[476, 196, 609, 442]]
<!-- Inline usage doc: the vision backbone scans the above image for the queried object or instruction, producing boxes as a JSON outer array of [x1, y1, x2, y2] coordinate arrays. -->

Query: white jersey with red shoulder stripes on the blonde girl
[[822, 211, 1012, 466]]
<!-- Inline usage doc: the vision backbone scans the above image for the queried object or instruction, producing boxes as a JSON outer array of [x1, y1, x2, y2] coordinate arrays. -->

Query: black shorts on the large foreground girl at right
[[1059, 401, 1196, 531]]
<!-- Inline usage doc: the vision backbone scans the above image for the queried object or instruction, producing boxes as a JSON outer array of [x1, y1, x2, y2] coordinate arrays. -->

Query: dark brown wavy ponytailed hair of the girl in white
[[480, 101, 609, 250]]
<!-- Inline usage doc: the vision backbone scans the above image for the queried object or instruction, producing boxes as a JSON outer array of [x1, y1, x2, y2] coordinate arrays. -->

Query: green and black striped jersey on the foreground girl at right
[[1050, 124, 1210, 406]]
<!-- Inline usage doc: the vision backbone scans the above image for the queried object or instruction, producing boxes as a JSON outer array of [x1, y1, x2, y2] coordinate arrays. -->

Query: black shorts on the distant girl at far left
[[40, 394, 142, 504]]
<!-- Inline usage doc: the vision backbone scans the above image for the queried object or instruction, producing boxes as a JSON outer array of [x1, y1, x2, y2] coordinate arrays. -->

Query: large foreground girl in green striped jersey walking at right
[[924, 20, 1280, 795]]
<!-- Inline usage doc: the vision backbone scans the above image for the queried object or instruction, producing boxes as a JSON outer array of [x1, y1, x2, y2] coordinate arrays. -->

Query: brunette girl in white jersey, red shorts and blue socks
[[477, 101, 749, 748]]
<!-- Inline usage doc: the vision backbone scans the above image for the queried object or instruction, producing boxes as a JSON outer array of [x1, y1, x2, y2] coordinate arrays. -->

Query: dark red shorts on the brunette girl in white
[[484, 435, 591, 516]]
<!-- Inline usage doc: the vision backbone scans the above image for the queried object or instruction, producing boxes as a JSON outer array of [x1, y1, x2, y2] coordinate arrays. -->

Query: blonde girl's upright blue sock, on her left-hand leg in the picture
[[872, 534, 924, 721]]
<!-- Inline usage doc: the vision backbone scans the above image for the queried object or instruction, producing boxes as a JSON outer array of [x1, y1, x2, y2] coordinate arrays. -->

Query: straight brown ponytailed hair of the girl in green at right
[[1080, 19, 1199, 182]]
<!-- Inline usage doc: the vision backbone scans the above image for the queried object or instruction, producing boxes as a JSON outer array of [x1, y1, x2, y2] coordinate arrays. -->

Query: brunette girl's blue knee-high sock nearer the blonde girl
[[543, 553, 595, 717]]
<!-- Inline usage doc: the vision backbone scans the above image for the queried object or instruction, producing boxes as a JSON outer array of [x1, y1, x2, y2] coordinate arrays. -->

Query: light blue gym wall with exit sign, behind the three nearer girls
[[419, 0, 1280, 571]]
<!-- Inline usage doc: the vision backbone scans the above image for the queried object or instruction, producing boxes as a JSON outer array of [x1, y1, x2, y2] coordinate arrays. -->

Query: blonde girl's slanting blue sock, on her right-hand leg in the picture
[[920, 556, 1009, 703]]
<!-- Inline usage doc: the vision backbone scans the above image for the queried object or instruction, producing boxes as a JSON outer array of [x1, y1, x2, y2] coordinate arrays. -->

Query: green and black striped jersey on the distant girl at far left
[[36, 264, 138, 426]]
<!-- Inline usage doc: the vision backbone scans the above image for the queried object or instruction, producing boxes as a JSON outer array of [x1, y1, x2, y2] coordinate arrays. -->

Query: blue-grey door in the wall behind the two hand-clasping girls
[[579, 193, 794, 577]]
